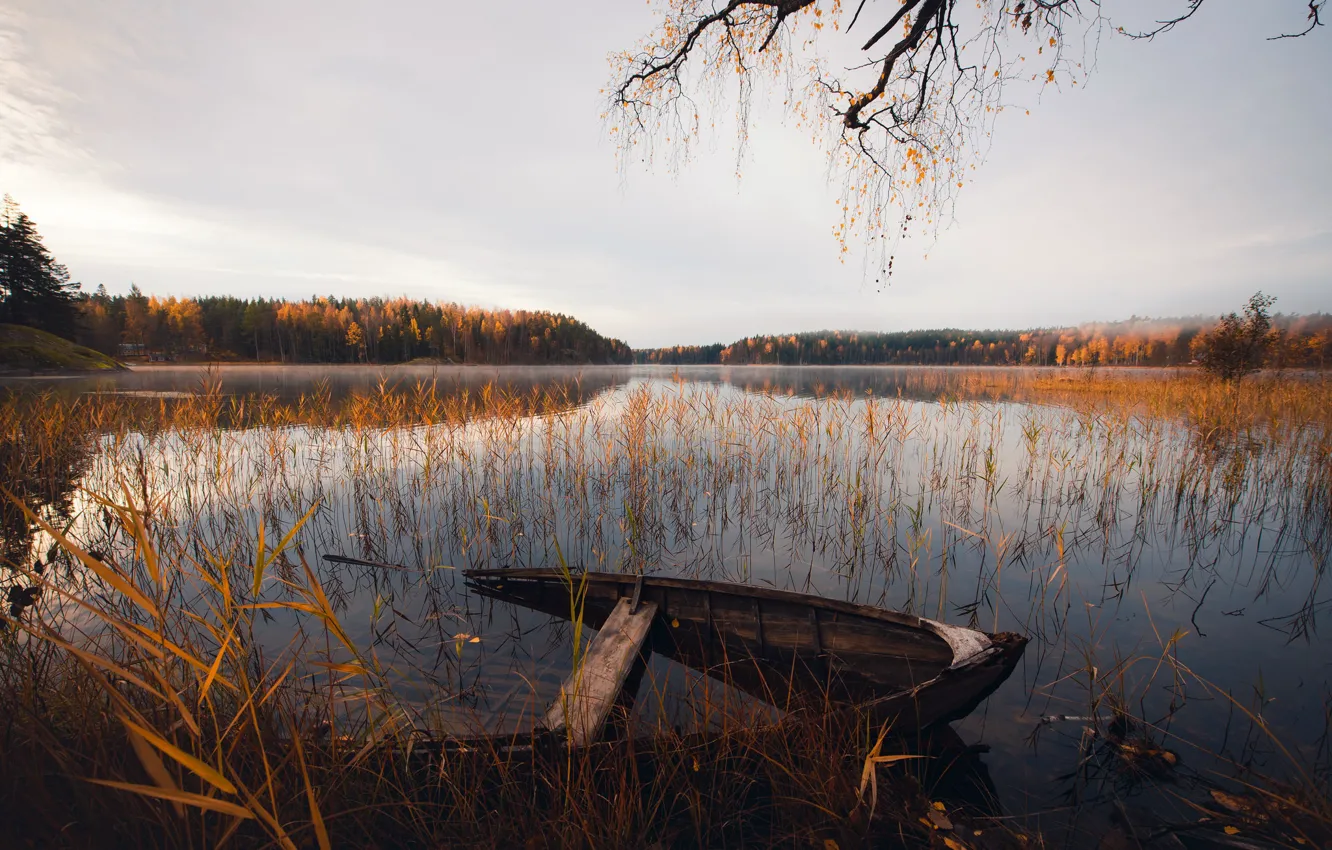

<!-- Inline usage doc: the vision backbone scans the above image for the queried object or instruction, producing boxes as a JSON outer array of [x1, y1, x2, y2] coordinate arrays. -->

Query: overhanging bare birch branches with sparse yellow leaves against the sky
[[606, 0, 1325, 274]]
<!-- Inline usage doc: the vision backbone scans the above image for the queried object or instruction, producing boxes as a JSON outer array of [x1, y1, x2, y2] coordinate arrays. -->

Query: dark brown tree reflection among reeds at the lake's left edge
[[0, 396, 93, 565]]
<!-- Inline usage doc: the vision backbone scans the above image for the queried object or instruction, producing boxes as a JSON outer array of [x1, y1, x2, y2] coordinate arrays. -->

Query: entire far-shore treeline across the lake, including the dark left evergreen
[[10, 196, 1332, 380]]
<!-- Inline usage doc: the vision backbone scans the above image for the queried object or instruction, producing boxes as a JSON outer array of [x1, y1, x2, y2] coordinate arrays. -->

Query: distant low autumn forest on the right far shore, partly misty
[[634, 313, 1332, 369]]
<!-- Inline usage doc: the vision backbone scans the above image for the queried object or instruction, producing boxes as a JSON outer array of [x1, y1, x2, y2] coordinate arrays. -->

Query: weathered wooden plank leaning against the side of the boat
[[543, 598, 657, 746]]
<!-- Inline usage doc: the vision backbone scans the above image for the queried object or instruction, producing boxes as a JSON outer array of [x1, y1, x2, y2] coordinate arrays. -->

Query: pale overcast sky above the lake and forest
[[0, 0, 1332, 346]]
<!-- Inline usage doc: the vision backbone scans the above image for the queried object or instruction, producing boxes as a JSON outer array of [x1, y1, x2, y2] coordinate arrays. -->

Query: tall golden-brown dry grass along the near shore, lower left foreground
[[0, 490, 1007, 847]]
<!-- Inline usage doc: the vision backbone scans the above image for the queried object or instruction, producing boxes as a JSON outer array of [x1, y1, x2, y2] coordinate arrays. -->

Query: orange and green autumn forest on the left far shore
[[75, 288, 633, 364]]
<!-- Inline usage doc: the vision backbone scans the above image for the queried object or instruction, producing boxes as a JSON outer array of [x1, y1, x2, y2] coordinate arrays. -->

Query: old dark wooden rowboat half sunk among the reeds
[[464, 569, 1027, 733]]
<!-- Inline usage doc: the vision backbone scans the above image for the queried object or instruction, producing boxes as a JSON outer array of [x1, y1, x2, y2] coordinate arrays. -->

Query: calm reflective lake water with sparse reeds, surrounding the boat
[[5, 366, 1332, 847]]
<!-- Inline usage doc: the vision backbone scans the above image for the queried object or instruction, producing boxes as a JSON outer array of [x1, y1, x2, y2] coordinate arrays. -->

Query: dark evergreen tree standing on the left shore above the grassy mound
[[0, 195, 79, 338]]
